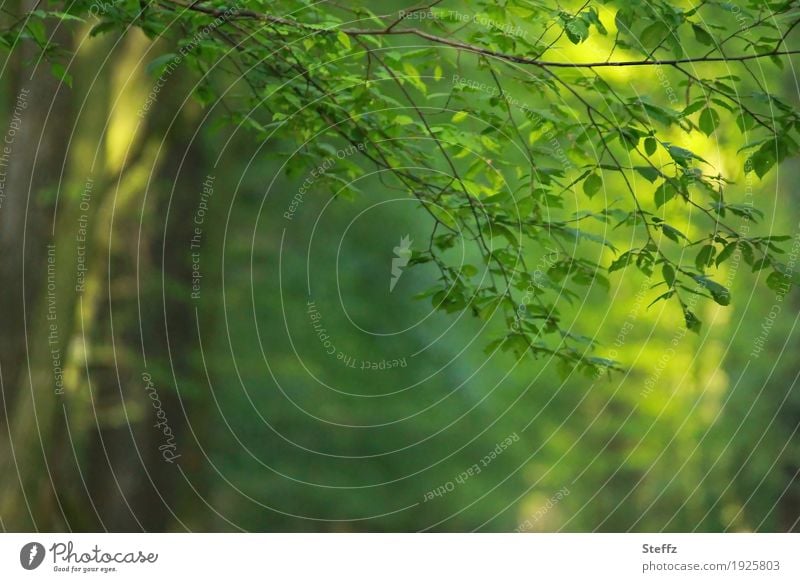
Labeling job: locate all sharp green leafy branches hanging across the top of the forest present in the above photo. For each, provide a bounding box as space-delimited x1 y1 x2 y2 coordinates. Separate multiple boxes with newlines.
3 0 800 376
